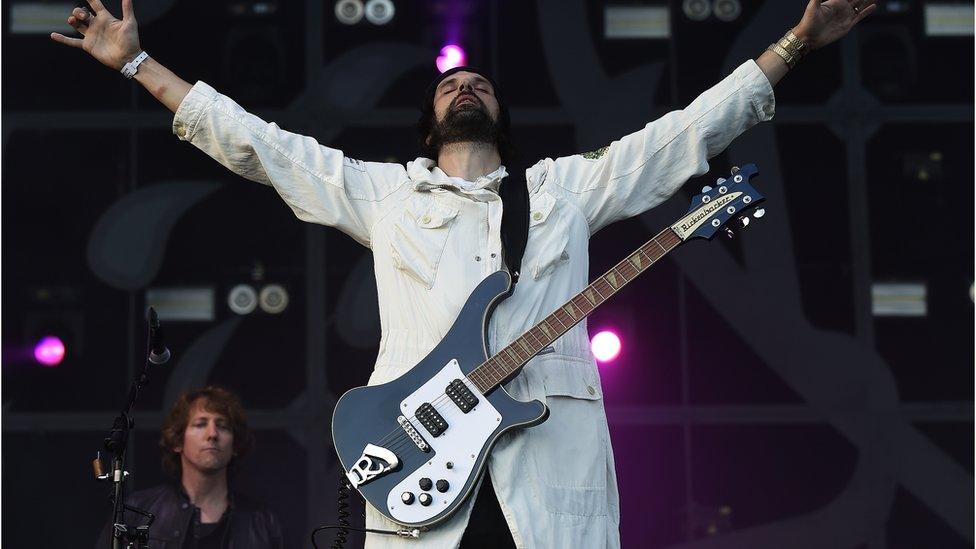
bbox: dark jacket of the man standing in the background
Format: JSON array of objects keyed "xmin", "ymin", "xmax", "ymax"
[{"xmin": 95, "ymin": 484, "xmax": 283, "ymax": 549}]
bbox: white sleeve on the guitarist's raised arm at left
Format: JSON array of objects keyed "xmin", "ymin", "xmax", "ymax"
[{"xmin": 173, "ymin": 82, "xmax": 407, "ymax": 246}]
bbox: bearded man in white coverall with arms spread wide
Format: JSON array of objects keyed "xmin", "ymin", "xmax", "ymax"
[{"xmin": 52, "ymin": 0, "xmax": 875, "ymax": 549}]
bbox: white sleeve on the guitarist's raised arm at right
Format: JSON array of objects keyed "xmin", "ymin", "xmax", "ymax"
[{"xmin": 545, "ymin": 60, "xmax": 775, "ymax": 234}]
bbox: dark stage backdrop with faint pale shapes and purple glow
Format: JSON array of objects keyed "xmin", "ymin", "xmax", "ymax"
[{"xmin": 2, "ymin": 0, "xmax": 974, "ymax": 549}]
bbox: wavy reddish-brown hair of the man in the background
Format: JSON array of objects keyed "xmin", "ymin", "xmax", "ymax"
[{"xmin": 159, "ymin": 385, "xmax": 254, "ymax": 479}]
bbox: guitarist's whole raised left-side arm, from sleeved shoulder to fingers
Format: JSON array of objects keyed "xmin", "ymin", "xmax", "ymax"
[{"xmin": 51, "ymin": 0, "xmax": 407, "ymax": 246}]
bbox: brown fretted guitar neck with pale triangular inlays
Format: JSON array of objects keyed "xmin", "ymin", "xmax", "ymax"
[{"xmin": 468, "ymin": 227, "xmax": 683, "ymax": 393}]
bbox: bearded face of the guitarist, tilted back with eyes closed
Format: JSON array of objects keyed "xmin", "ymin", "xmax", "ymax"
[{"xmin": 428, "ymin": 71, "xmax": 500, "ymax": 150}]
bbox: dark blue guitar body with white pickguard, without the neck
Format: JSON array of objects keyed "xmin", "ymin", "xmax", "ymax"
[{"xmin": 332, "ymin": 271, "xmax": 549, "ymax": 527}]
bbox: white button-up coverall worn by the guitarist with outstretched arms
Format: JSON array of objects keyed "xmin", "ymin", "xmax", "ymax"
[{"xmin": 173, "ymin": 60, "xmax": 774, "ymax": 549}]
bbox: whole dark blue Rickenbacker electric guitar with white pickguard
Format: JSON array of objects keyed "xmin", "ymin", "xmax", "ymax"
[{"xmin": 332, "ymin": 164, "xmax": 765, "ymax": 529}]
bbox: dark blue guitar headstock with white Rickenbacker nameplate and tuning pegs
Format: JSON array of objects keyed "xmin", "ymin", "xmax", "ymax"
[{"xmin": 671, "ymin": 164, "xmax": 766, "ymax": 240}]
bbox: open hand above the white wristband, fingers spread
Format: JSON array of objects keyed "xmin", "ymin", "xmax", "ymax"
[{"xmin": 51, "ymin": 0, "xmax": 142, "ymax": 70}]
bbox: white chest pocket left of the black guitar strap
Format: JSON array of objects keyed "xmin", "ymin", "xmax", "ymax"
[{"xmin": 390, "ymin": 199, "xmax": 458, "ymax": 290}]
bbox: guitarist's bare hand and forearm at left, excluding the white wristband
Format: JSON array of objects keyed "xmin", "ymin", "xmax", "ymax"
[{"xmin": 51, "ymin": 0, "xmax": 191, "ymax": 113}]
